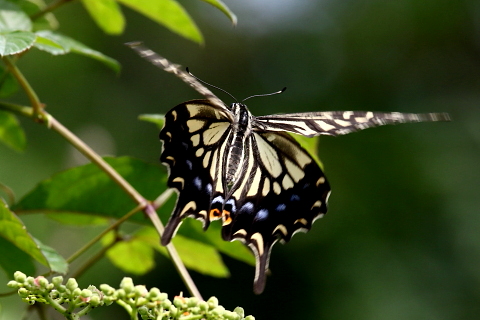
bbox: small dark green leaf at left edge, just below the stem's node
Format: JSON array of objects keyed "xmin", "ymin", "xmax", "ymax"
[{"xmin": 0, "ymin": 110, "xmax": 27, "ymax": 151}]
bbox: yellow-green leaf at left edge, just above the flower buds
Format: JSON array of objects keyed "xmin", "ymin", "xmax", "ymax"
[{"xmin": 0, "ymin": 199, "xmax": 48, "ymax": 266}]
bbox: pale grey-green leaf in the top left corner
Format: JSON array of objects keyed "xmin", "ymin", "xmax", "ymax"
[{"xmin": 0, "ymin": 0, "xmax": 32, "ymax": 33}]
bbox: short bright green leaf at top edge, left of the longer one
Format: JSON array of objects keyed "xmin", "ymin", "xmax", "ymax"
[{"xmin": 82, "ymin": 0, "xmax": 125, "ymax": 35}]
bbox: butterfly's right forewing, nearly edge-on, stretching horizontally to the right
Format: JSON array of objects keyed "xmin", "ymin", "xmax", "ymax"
[{"xmin": 253, "ymin": 111, "xmax": 450, "ymax": 137}]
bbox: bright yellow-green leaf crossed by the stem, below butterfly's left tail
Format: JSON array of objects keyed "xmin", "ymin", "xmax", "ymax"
[{"xmin": 135, "ymin": 228, "xmax": 230, "ymax": 278}]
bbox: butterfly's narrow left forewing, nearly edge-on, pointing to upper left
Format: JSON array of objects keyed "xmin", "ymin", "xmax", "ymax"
[{"xmin": 126, "ymin": 42, "xmax": 233, "ymax": 122}]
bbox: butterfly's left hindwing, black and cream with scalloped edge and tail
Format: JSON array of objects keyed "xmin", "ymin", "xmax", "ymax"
[{"xmin": 160, "ymin": 100, "xmax": 231, "ymax": 245}]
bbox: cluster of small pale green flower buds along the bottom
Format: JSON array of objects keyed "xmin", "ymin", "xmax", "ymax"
[{"xmin": 8, "ymin": 271, "xmax": 255, "ymax": 320}]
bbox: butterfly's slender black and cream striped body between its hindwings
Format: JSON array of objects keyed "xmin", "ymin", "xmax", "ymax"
[{"xmin": 225, "ymin": 103, "xmax": 252, "ymax": 189}]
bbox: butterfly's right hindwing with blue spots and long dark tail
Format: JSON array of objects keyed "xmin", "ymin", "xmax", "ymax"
[{"xmin": 222, "ymin": 133, "xmax": 330, "ymax": 294}]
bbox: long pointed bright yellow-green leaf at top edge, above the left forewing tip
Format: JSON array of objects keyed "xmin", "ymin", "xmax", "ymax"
[{"xmin": 117, "ymin": 0, "xmax": 203, "ymax": 43}]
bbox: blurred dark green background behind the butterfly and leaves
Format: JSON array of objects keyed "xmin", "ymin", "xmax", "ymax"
[{"xmin": 0, "ymin": 0, "xmax": 480, "ymax": 320}]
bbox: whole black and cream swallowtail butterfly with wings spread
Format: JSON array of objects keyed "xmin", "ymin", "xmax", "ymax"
[{"xmin": 127, "ymin": 43, "xmax": 450, "ymax": 294}]
